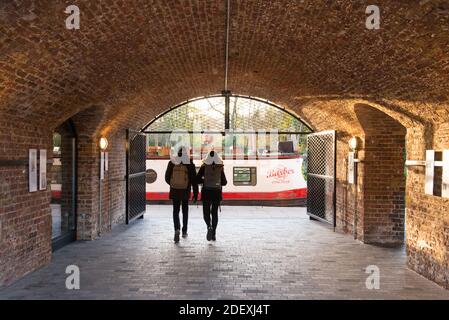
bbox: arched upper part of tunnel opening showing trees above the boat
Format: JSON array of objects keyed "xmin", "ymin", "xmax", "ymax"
[{"xmin": 142, "ymin": 95, "xmax": 312, "ymax": 157}]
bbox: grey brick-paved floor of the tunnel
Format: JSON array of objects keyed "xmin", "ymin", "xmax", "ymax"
[{"xmin": 0, "ymin": 206, "xmax": 449, "ymax": 299}]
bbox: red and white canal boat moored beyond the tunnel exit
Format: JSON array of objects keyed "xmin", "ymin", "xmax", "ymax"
[{"xmin": 146, "ymin": 154, "xmax": 307, "ymax": 205}]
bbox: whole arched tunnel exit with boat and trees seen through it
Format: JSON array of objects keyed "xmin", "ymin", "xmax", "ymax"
[{"xmin": 142, "ymin": 94, "xmax": 313, "ymax": 207}]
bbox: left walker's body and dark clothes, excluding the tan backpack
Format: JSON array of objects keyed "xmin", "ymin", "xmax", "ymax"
[{"xmin": 165, "ymin": 148, "xmax": 198, "ymax": 243}]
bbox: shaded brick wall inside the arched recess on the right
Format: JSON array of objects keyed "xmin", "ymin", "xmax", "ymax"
[{"xmin": 354, "ymin": 104, "xmax": 406, "ymax": 245}]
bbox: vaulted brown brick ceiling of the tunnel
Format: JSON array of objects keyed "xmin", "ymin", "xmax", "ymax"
[{"xmin": 0, "ymin": 0, "xmax": 449, "ymax": 132}]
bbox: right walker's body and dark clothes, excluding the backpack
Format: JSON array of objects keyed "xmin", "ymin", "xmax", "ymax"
[{"xmin": 196, "ymin": 151, "xmax": 228, "ymax": 241}]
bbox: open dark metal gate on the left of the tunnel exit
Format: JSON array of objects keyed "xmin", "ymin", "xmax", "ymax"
[{"xmin": 126, "ymin": 129, "xmax": 147, "ymax": 224}]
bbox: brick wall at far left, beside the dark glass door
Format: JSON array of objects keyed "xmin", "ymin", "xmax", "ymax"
[{"xmin": 0, "ymin": 117, "xmax": 52, "ymax": 286}]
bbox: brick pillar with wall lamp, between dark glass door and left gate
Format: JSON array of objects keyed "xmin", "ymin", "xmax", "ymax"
[{"xmin": 72, "ymin": 107, "xmax": 126, "ymax": 240}]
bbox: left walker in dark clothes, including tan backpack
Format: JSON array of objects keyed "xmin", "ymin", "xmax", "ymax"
[{"xmin": 165, "ymin": 147, "xmax": 198, "ymax": 243}]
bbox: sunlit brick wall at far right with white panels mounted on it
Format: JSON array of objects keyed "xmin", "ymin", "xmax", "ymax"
[{"xmin": 407, "ymin": 123, "xmax": 449, "ymax": 289}]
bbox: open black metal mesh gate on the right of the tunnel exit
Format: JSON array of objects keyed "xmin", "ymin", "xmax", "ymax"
[{"xmin": 307, "ymin": 131, "xmax": 337, "ymax": 228}]
